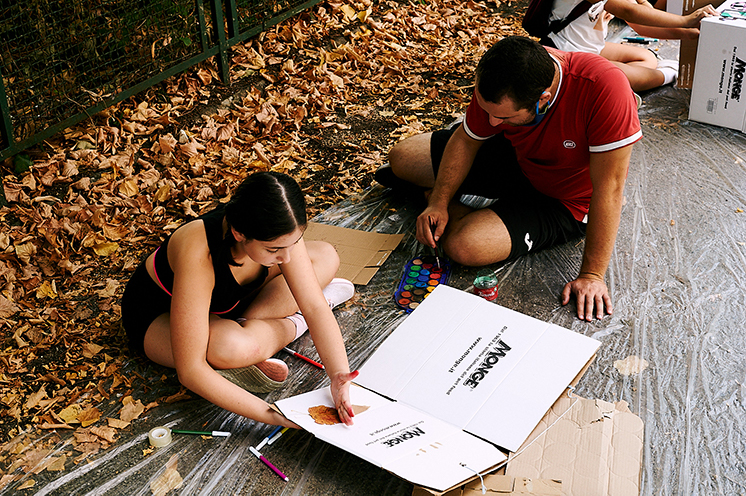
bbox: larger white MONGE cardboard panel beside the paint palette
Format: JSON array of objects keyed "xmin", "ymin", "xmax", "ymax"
[{"xmin": 357, "ymin": 286, "xmax": 600, "ymax": 451}]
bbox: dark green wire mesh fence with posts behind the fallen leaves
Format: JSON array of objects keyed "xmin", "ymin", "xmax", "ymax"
[{"xmin": 0, "ymin": 0, "xmax": 317, "ymax": 159}]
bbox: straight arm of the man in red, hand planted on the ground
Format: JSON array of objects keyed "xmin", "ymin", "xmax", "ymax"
[{"xmin": 562, "ymin": 145, "xmax": 632, "ymax": 321}]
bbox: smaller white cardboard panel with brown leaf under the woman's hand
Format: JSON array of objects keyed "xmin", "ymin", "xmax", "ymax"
[{"xmin": 276, "ymin": 386, "xmax": 507, "ymax": 490}]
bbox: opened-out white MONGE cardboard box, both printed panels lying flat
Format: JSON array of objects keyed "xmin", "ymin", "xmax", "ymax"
[{"xmin": 276, "ymin": 285, "xmax": 600, "ymax": 492}]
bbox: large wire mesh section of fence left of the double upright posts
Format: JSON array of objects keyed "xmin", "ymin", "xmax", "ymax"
[{"xmin": 0, "ymin": 0, "xmax": 202, "ymax": 144}]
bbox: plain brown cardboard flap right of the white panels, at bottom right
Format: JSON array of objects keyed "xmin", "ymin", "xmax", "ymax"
[{"xmin": 506, "ymin": 395, "xmax": 644, "ymax": 496}]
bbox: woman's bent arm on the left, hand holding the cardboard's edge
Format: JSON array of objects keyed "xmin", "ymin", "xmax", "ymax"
[{"xmin": 168, "ymin": 222, "xmax": 296, "ymax": 427}]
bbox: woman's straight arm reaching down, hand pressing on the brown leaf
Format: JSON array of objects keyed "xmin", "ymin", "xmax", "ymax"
[{"xmin": 280, "ymin": 239, "xmax": 357, "ymax": 425}]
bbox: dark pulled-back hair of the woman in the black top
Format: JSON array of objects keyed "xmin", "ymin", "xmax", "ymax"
[{"xmin": 224, "ymin": 172, "xmax": 308, "ymax": 260}]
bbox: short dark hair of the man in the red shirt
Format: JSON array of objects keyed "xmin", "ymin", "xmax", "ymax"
[{"xmin": 476, "ymin": 36, "xmax": 555, "ymax": 110}]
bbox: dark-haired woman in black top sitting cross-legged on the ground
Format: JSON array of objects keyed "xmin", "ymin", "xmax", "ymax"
[{"xmin": 122, "ymin": 172, "xmax": 357, "ymax": 427}]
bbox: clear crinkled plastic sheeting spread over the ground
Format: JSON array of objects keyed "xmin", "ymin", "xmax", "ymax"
[{"xmin": 8, "ymin": 47, "xmax": 746, "ymax": 495}]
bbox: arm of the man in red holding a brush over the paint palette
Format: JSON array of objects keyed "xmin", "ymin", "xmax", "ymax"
[{"xmin": 417, "ymin": 125, "xmax": 483, "ymax": 248}]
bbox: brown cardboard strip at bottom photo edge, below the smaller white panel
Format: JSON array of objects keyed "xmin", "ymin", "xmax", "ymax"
[{"xmin": 412, "ymin": 474, "xmax": 562, "ymax": 496}]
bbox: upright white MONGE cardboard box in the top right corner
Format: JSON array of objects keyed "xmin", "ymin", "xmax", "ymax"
[{"xmin": 689, "ymin": 0, "xmax": 746, "ymax": 131}]
